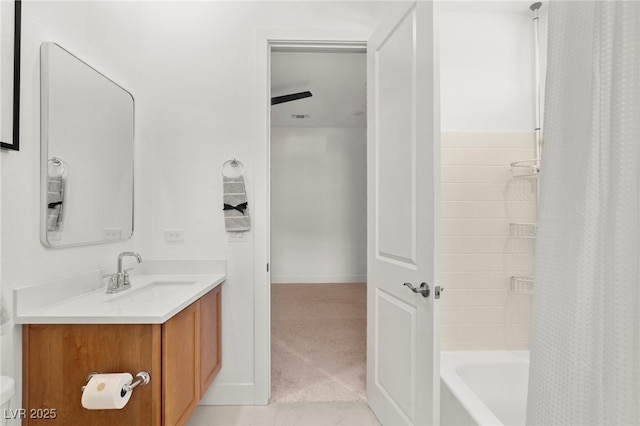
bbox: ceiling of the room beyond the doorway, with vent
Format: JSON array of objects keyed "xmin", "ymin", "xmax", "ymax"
[{"xmin": 271, "ymin": 51, "xmax": 367, "ymax": 127}]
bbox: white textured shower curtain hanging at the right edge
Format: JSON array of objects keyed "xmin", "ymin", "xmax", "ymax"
[{"xmin": 527, "ymin": 1, "xmax": 640, "ymax": 425}]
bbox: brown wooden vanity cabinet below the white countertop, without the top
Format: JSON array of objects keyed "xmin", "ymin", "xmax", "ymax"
[{"xmin": 20, "ymin": 285, "xmax": 222, "ymax": 426}]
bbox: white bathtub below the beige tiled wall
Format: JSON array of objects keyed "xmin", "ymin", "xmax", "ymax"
[{"xmin": 440, "ymin": 351, "xmax": 529, "ymax": 426}]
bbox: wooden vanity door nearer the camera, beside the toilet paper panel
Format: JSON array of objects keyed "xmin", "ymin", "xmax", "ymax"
[{"xmin": 162, "ymin": 300, "xmax": 200, "ymax": 426}]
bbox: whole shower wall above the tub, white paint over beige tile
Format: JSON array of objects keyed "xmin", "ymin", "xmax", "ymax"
[{"xmin": 440, "ymin": 1, "xmax": 547, "ymax": 350}]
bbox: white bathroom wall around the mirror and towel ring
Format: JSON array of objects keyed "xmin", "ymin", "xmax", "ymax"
[{"xmin": 2, "ymin": 1, "xmax": 388, "ymax": 406}]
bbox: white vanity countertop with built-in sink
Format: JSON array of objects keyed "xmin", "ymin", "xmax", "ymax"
[{"xmin": 14, "ymin": 261, "xmax": 226, "ymax": 324}]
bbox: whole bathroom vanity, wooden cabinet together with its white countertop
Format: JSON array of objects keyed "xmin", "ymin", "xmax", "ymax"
[{"xmin": 16, "ymin": 262, "xmax": 225, "ymax": 426}]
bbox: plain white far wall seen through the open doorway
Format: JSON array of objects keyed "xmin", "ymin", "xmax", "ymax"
[{"xmin": 271, "ymin": 127, "xmax": 367, "ymax": 283}]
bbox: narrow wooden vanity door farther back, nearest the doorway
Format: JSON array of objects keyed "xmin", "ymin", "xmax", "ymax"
[{"xmin": 200, "ymin": 285, "xmax": 222, "ymax": 397}]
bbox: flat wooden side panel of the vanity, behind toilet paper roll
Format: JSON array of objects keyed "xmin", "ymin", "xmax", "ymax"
[{"xmin": 22, "ymin": 324, "xmax": 162, "ymax": 426}]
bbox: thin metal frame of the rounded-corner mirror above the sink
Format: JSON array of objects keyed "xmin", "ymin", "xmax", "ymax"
[{"xmin": 40, "ymin": 42, "xmax": 136, "ymax": 249}]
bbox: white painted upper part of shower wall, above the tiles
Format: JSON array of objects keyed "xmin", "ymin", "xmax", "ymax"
[{"xmin": 440, "ymin": 1, "xmax": 547, "ymax": 132}]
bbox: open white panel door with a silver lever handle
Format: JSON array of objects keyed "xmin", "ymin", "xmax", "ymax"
[{"xmin": 367, "ymin": 1, "xmax": 440, "ymax": 425}]
